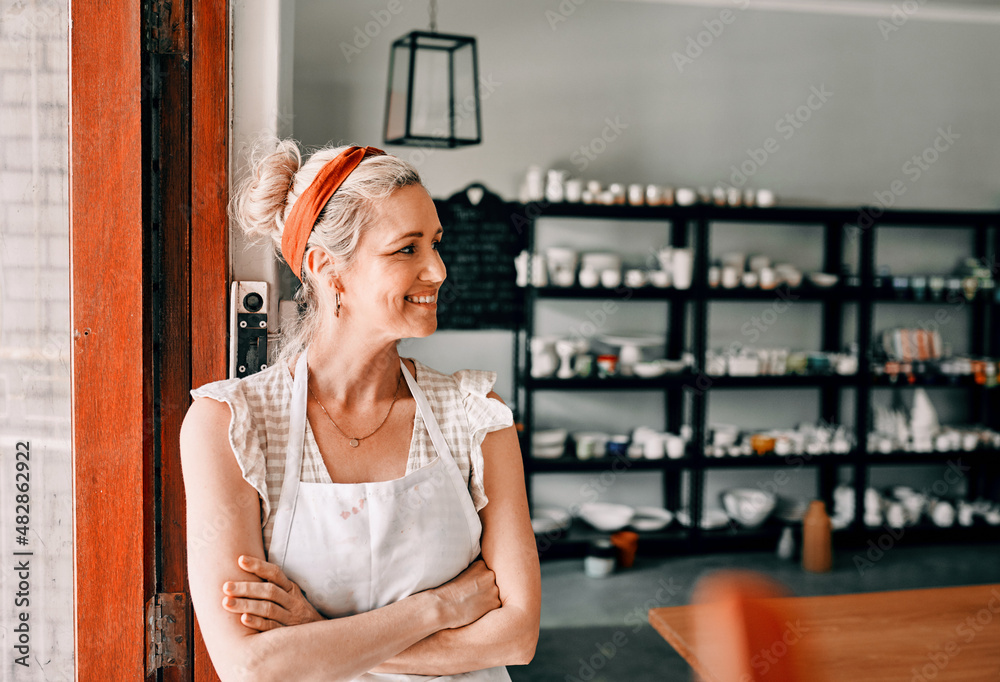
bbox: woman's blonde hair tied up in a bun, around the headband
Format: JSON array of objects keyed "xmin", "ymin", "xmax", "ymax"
[{"xmin": 229, "ymin": 138, "xmax": 423, "ymax": 363}]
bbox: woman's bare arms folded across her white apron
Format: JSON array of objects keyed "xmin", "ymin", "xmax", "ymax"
[{"xmin": 181, "ymin": 394, "xmax": 540, "ymax": 680}]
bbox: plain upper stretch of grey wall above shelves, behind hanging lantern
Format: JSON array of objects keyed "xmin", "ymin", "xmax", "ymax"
[{"xmin": 294, "ymin": 0, "xmax": 1000, "ymax": 208}]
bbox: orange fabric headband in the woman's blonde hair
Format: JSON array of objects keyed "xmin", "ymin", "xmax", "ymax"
[{"xmin": 281, "ymin": 147, "xmax": 385, "ymax": 280}]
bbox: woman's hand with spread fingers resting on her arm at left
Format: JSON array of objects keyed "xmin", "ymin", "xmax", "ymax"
[{"xmin": 222, "ymin": 555, "xmax": 325, "ymax": 632}]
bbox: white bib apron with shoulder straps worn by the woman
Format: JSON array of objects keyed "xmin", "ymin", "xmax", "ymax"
[{"xmin": 268, "ymin": 349, "xmax": 510, "ymax": 682}]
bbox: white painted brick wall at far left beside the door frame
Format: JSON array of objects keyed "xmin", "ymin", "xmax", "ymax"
[{"xmin": 0, "ymin": 0, "xmax": 73, "ymax": 682}]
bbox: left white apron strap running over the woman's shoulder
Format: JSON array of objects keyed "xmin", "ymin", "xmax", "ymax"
[{"xmin": 267, "ymin": 348, "xmax": 309, "ymax": 566}]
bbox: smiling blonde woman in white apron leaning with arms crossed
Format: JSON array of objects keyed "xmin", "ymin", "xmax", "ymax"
[{"xmin": 181, "ymin": 141, "xmax": 540, "ymax": 681}]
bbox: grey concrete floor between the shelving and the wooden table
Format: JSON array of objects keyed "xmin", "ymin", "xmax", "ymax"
[{"xmin": 508, "ymin": 545, "xmax": 1000, "ymax": 682}]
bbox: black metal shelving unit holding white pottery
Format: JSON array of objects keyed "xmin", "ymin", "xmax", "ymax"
[{"xmin": 515, "ymin": 199, "xmax": 1000, "ymax": 557}]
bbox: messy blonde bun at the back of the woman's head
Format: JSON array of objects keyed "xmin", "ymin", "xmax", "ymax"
[{"xmin": 231, "ymin": 138, "xmax": 302, "ymax": 249}]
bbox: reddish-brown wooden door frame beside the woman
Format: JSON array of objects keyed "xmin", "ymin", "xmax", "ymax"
[{"xmin": 69, "ymin": 0, "xmax": 230, "ymax": 682}]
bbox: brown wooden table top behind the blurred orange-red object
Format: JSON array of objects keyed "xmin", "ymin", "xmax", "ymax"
[{"xmin": 649, "ymin": 584, "xmax": 1000, "ymax": 682}]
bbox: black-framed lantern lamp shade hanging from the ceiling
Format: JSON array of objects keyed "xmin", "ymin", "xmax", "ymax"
[{"xmin": 385, "ymin": 31, "xmax": 482, "ymax": 147}]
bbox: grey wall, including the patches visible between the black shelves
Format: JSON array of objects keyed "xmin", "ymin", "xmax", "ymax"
[{"xmin": 294, "ymin": 0, "xmax": 1000, "ymax": 505}]
